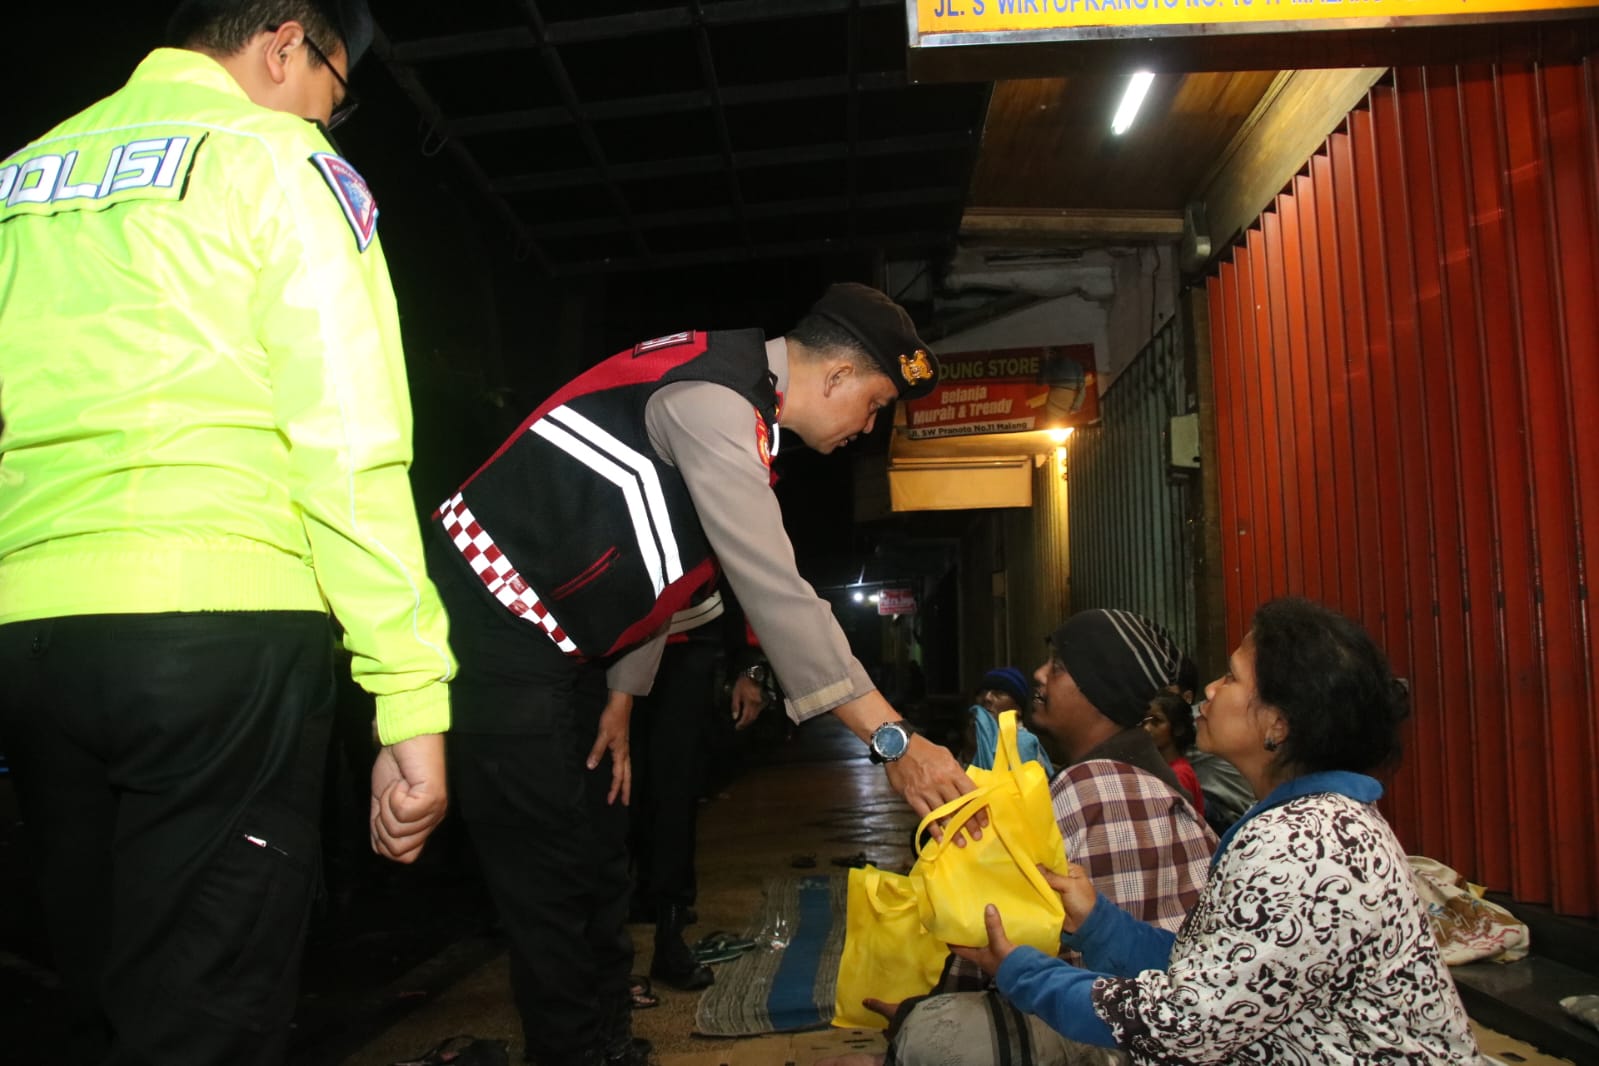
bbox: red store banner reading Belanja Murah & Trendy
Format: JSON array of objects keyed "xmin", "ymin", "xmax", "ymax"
[{"xmin": 905, "ymin": 344, "xmax": 1099, "ymax": 441}]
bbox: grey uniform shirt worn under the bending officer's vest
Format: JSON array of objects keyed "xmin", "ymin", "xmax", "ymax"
[{"xmin": 606, "ymin": 340, "xmax": 876, "ymax": 722}]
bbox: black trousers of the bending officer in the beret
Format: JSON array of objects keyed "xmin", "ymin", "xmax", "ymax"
[{"xmin": 429, "ymin": 539, "xmax": 633, "ymax": 1066}]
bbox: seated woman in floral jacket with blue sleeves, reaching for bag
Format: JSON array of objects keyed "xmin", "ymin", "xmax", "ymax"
[{"xmin": 955, "ymin": 599, "xmax": 1482, "ymax": 1066}]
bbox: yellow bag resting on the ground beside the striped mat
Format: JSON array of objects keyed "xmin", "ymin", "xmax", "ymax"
[{"xmin": 833, "ymin": 866, "xmax": 950, "ymax": 1029}]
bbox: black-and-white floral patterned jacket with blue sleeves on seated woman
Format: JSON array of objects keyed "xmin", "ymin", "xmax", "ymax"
[{"xmin": 998, "ymin": 774, "xmax": 1482, "ymax": 1066}]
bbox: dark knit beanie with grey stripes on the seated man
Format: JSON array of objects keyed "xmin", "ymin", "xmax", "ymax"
[{"xmin": 1049, "ymin": 609, "xmax": 1183, "ymax": 726}]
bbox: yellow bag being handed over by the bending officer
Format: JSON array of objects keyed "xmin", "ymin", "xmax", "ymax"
[{"xmin": 910, "ymin": 711, "xmax": 1067, "ymax": 956}]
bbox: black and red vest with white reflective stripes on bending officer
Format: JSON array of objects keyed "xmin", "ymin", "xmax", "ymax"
[{"xmin": 433, "ymin": 329, "xmax": 777, "ymax": 658}]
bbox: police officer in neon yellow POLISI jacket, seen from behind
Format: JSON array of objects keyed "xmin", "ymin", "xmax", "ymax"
[{"xmin": 0, "ymin": 0, "xmax": 454, "ymax": 1064}]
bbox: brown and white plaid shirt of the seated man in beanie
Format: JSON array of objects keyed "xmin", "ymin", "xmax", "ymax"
[{"xmin": 937, "ymin": 750, "xmax": 1217, "ymax": 992}]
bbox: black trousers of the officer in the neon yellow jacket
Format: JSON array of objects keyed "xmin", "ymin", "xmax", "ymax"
[{"xmin": 0, "ymin": 612, "xmax": 334, "ymax": 1066}]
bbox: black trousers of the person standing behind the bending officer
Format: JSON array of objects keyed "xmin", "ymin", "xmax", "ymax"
[{"xmin": 632, "ymin": 641, "xmax": 719, "ymax": 908}]
